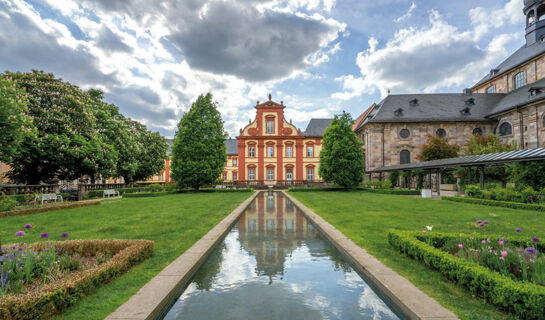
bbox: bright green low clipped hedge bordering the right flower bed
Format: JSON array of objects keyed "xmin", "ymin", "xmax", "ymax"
[{"xmin": 388, "ymin": 230, "xmax": 545, "ymax": 319}]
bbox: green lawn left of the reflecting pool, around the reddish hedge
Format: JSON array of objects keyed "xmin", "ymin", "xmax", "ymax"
[{"xmin": 0, "ymin": 192, "xmax": 251, "ymax": 320}]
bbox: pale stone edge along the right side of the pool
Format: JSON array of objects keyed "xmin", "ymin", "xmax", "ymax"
[{"xmin": 282, "ymin": 191, "xmax": 459, "ymax": 320}]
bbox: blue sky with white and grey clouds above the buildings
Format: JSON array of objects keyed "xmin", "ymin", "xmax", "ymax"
[{"xmin": 0, "ymin": 0, "xmax": 525, "ymax": 137}]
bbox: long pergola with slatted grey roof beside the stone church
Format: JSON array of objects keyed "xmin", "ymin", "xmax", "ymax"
[{"xmin": 365, "ymin": 148, "xmax": 545, "ymax": 194}]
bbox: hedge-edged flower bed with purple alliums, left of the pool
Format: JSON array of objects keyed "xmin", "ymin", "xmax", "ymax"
[{"xmin": 0, "ymin": 239, "xmax": 153, "ymax": 319}]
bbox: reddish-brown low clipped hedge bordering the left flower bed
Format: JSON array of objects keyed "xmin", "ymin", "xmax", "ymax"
[{"xmin": 0, "ymin": 239, "xmax": 153, "ymax": 320}]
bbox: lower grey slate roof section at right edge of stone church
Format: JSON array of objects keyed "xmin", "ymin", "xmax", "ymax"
[{"xmin": 489, "ymin": 78, "xmax": 545, "ymax": 116}]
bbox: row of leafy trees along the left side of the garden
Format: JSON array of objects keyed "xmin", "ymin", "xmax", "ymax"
[{"xmin": 0, "ymin": 70, "xmax": 168, "ymax": 184}]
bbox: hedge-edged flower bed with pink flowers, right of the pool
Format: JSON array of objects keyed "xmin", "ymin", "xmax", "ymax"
[{"xmin": 388, "ymin": 230, "xmax": 545, "ymax": 319}]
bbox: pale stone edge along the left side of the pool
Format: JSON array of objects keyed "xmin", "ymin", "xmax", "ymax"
[{"xmin": 106, "ymin": 191, "xmax": 259, "ymax": 320}]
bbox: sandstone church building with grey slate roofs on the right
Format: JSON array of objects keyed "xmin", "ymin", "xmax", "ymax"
[{"xmin": 353, "ymin": 0, "xmax": 545, "ymax": 171}]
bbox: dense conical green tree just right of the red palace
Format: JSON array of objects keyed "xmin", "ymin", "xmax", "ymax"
[{"xmin": 320, "ymin": 111, "xmax": 365, "ymax": 189}]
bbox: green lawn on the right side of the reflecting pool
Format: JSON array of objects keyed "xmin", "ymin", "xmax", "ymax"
[{"xmin": 291, "ymin": 191, "xmax": 545, "ymax": 320}]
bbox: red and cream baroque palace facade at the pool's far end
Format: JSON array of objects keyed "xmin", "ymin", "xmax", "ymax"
[{"xmin": 221, "ymin": 94, "xmax": 331, "ymax": 185}]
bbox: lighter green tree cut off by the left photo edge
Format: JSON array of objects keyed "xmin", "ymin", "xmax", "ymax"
[{"xmin": 0, "ymin": 74, "xmax": 34, "ymax": 163}]
